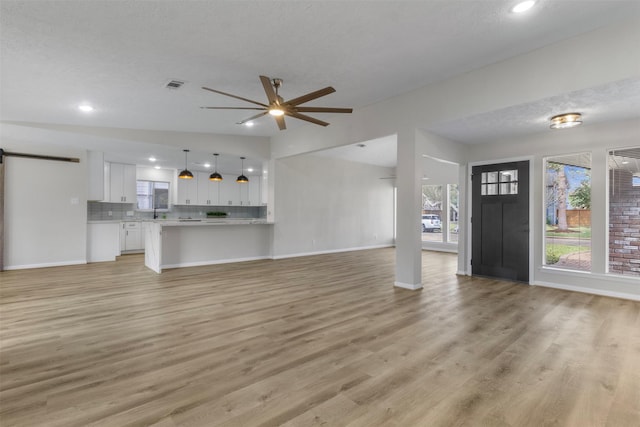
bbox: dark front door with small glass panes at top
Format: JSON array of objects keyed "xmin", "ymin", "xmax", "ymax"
[{"xmin": 471, "ymin": 161, "xmax": 529, "ymax": 282}]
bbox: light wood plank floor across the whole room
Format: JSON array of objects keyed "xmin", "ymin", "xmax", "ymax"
[{"xmin": 0, "ymin": 249, "xmax": 640, "ymax": 427}]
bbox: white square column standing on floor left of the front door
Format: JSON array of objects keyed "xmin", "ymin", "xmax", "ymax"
[{"xmin": 395, "ymin": 131, "xmax": 422, "ymax": 289}]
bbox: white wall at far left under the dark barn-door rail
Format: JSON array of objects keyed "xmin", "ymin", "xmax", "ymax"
[{"xmin": 2, "ymin": 140, "xmax": 87, "ymax": 270}]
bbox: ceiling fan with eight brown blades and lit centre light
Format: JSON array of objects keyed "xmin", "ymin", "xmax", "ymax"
[{"xmin": 200, "ymin": 76, "xmax": 353, "ymax": 130}]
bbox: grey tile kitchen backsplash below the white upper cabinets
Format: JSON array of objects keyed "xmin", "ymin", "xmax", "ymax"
[{"xmin": 87, "ymin": 202, "xmax": 267, "ymax": 221}]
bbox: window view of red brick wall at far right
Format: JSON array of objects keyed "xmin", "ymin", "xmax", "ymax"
[{"xmin": 609, "ymin": 147, "xmax": 640, "ymax": 276}]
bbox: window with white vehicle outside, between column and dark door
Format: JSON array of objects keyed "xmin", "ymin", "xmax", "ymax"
[{"xmin": 422, "ymin": 184, "xmax": 458, "ymax": 243}]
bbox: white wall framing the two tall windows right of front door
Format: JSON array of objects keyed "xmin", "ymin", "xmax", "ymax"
[{"xmin": 467, "ymin": 119, "xmax": 640, "ymax": 299}]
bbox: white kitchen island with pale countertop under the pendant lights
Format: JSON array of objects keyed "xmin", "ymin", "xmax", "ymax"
[{"xmin": 144, "ymin": 219, "xmax": 273, "ymax": 273}]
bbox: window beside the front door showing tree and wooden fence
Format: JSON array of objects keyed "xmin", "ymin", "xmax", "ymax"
[{"xmin": 545, "ymin": 153, "xmax": 591, "ymax": 271}]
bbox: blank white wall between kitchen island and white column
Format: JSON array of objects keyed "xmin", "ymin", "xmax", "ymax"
[{"xmin": 274, "ymin": 155, "xmax": 394, "ymax": 257}]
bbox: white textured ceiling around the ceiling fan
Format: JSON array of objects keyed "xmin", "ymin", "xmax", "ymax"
[{"xmin": 0, "ymin": 0, "xmax": 640, "ymax": 168}]
